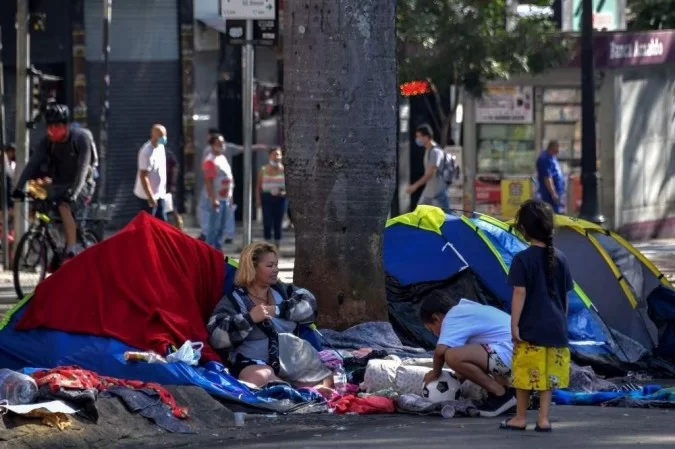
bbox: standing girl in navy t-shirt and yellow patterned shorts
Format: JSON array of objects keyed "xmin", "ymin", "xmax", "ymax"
[{"xmin": 500, "ymin": 200, "xmax": 574, "ymax": 432}]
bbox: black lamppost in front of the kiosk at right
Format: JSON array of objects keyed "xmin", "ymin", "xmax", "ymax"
[{"xmin": 579, "ymin": 0, "xmax": 605, "ymax": 224}]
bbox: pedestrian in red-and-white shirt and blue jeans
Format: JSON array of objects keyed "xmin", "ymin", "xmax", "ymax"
[{"xmin": 201, "ymin": 134, "xmax": 232, "ymax": 250}]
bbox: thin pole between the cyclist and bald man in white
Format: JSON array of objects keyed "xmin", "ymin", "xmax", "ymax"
[{"xmin": 98, "ymin": 0, "xmax": 112, "ymax": 203}]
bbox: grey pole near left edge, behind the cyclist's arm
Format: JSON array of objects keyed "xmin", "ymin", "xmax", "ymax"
[{"xmin": 14, "ymin": 0, "xmax": 30, "ymax": 242}]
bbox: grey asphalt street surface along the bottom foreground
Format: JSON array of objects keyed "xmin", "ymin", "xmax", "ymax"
[{"xmin": 145, "ymin": 406, "xmax": 675, "ymax": 449}]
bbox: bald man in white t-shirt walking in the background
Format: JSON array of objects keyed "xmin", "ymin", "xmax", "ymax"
[{"xmin": 134, "ymin": 124, "xmax": 167, "ymax": 221}]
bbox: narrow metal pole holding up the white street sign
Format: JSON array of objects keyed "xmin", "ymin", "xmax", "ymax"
[{"xmin": 241, "ymin": 20, "xmax": 254, "ymax": 246}]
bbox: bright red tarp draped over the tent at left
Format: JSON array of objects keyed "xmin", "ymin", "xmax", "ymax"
[{"xmin": 17, "ymin": 212, "xmax": 225, "ymax": 361}]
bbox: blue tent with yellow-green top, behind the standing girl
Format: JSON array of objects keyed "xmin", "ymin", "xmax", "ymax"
[{"xmin": 384, "ymin": 206, "xmax": 629, "ymax": 367}]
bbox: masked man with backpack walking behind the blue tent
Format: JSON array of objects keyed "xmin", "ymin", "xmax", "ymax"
[{"xmin": 406, "ymin": 125, "xmax": 450, "ymax": 211}]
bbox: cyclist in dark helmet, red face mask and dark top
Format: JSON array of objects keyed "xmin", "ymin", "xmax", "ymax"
[{"xmin": 12, "ymin": 102, "xmax": 95, "ymax": 258}]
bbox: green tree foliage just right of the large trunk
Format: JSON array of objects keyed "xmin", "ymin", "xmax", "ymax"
[{"xmin": 397, "ymin": 0, "xmax": 569, "ymax": 101}]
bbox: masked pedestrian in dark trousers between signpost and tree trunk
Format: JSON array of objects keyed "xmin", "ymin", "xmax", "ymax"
[{"xmin": 256, "ymin": 148, "xmax": 287, "ymax": 248}]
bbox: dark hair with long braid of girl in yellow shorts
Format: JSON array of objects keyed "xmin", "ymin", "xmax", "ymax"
[{"xmin": 516, "ymin": 200, "xmax": 557, "ymax": 298}]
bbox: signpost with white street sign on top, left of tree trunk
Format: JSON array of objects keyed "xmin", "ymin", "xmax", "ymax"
[{"xmin": 220, "ymin": 0, "xmax": 278, "ymax": 246}]
